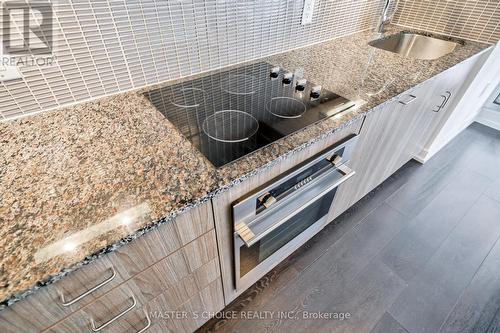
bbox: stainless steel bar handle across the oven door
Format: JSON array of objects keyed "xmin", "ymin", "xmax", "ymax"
[{"xmin": 235, "ymin": 164, "xmax": 356, "ymax": 247}]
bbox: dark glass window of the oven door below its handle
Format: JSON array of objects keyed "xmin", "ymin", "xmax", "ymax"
[{"xmin": 239, "ymin": 188, "xmax": 337, "ymax": 278}]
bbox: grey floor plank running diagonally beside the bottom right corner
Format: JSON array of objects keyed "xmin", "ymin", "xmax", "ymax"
[{"xmin": 389, "ymin": 196, "xmax": 500, "ymax": 333}]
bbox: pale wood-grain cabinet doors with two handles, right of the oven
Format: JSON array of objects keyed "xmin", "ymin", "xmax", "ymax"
[{"xmin": 331, "ymin": 54, "xmax": 485, "ymax": 218}]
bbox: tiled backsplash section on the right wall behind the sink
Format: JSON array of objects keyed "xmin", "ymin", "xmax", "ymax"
[{"xmin": 393, "ymin": 0, "xmax": 500, "ymax": 43}]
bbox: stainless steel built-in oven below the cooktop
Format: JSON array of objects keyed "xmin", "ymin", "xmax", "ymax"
[{"xmin": 233, "ymin": 135, "xmax": 357, "ymax": 290}]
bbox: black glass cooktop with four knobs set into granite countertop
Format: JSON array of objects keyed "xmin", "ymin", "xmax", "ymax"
[{"xmin": 146, "ymin": 62, "xmax": 354, "ymax": 167}]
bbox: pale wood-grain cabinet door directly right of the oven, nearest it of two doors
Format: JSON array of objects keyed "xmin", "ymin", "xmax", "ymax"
[{"xmin": 331, "ymin": 90, "xmax": 421, "ymax": 219}]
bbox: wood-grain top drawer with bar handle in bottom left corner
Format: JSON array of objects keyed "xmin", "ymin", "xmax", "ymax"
[{"xmin": 0, "ymin": 256, "xmax": 123, "ymax": 333}]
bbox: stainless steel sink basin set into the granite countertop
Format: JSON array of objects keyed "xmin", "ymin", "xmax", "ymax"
[{"xmin": 368, "ymin": 32, "xmax": 458, "ymax": 60}]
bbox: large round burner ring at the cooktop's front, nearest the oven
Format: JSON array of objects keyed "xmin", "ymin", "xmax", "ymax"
[{"xmin": 202, "ymin": 110, "xmax": 259, "ymax": 143}]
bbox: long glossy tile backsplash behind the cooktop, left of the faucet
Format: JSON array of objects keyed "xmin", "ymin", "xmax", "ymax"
[{"xmin": 0, "ymin": 0, "xmax": 382, "ymax": 119}]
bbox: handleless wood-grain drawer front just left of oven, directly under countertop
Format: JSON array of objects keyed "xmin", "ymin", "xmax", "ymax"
[{"xmin": 110, "ymin": 202, "xmax": 214, "ymax": 279}]
